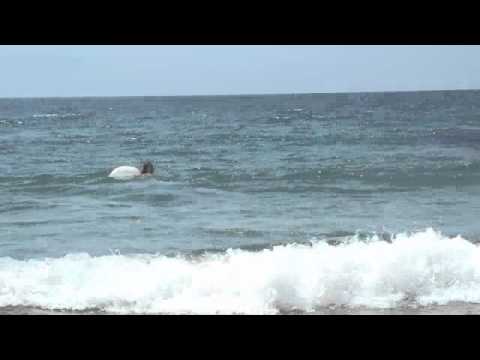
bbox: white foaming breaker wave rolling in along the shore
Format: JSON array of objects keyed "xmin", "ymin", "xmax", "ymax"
[{"xmin": 0, "ymin": 229, "xmax": 480, "ymax": 314}]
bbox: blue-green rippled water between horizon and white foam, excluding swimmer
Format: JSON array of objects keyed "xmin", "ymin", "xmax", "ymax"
[{"xmin": 0, "ymin": 91, "xmax": 480, "ymax": 314}]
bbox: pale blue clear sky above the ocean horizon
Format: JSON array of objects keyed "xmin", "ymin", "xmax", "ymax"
[{"xmin": 0, "ymin": 45, "xmax": 480, "ymax": 97}]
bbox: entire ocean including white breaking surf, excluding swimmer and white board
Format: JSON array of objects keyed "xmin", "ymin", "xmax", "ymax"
[{"xmin": 0, "ymin": 91, "xmax": 480, "ymax": 314}]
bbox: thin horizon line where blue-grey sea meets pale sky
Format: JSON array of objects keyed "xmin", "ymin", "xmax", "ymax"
[{"xmin": 0, "ymin": 88, "xmax": 480, "ymax": 100}]
